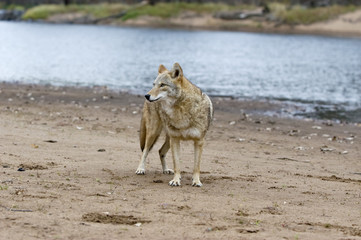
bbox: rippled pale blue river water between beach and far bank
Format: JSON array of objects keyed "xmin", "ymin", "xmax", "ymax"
[{"xmin": 0, "ymin": 22, "xmax": 361, "ymax": 122}]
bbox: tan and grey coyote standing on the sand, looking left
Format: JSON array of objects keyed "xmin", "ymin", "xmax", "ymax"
[{"xmin": 136, "ymin": 63, "xmax": 213, "ymax": 187}]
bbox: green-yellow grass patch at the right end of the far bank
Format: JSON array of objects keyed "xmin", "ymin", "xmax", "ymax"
[{"xmin": 270, "ymin": 3, "xmax": 357, "ymax": 25}]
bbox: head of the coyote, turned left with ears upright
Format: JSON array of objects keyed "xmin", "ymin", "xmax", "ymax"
[{"xmin": 145, "ymin": 63, "xmax": 183, "ymax": 102}]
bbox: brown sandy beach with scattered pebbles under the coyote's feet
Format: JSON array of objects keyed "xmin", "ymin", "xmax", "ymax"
[{"xmin": 0, "ymin": 83, "xmax": 361, "ymax": 240}]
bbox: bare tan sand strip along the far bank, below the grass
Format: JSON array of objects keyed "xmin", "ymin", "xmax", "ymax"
[{"xmin": 109, "ymin": 10, "xmax": 361, "ymax": 38}]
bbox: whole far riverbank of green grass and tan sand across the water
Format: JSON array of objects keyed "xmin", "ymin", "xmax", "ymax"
[{"xmin": 12, "ymin": 2, "xmax": 361, "ymax": 37}]
